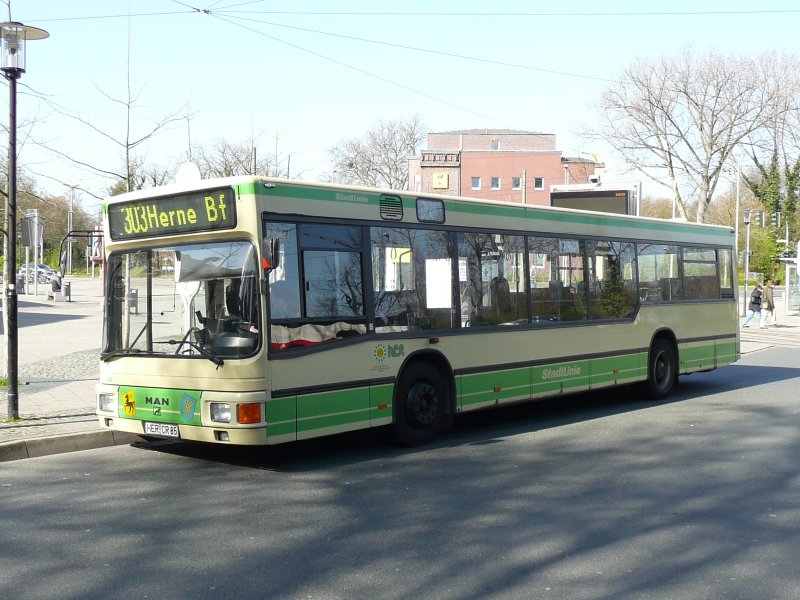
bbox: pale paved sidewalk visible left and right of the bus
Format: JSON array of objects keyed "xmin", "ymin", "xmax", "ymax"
[{"xmin": 0, "ymin": 278, "xmax": 800, "ymax": 462}]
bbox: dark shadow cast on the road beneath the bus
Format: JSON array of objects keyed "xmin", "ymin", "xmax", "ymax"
[{"xmin": 137, "ymin": 356, "xmax": 800, "ymax": 473}]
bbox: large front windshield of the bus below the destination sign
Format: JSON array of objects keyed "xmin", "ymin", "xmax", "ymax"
[{"xmin": 102, "ymin": 240, "xmax": 263, "ymax": 366}]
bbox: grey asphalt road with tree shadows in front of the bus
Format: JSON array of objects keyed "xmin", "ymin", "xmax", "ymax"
[{"xmin": 0, "ymin": 348, "xmax": 800, "ymax": 599}]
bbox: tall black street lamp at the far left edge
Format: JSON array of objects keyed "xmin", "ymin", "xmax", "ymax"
[{"xmin": 0, "ymin": 21, "xmax": 50, "ymax": 420}]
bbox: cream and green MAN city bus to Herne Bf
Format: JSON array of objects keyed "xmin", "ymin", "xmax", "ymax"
[{"xmin": 97, "ymin": 177, "xmax": 740, "ymax": 446}]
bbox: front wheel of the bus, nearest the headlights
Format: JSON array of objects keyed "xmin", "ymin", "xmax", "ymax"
[{"xmin": 393, "ymin": 361, "xmax": 448, "ymax": 446}]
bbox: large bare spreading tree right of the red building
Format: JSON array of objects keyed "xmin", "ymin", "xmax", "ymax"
[{"xmin": 589, "ymin": 49, "xmax": 798, "ymax": 222}]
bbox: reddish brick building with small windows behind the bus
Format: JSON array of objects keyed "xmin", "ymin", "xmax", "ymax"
[{"xmin": 408, "ymin": 129, "xmax": 603, "ymax": 205}]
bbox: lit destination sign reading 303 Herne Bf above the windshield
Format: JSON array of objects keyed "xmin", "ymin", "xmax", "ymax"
[{"xmin": 108, "ymin": 188, "xmax": 236, "ymax": 240}]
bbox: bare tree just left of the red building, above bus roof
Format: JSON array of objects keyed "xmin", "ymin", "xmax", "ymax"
[{"xmin": 329, "ymin": 115, "xmax": 425, "ymax": 190}]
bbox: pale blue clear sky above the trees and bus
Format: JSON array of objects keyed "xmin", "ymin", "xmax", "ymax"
[{"xmin": 6, "ymin": 0, "xmax": 800, "ymax": 212}]
